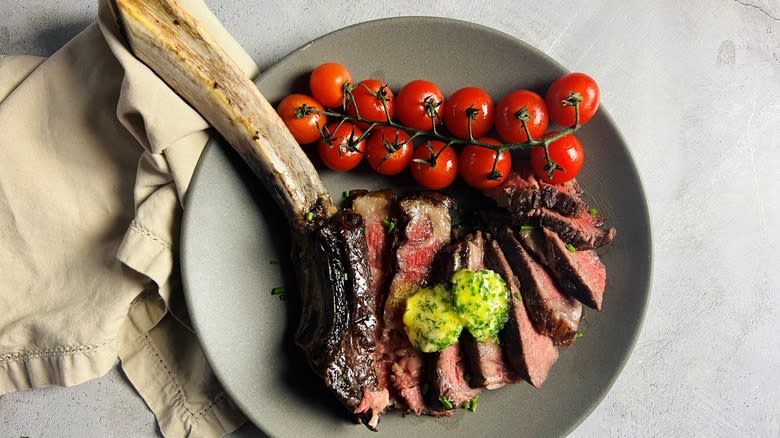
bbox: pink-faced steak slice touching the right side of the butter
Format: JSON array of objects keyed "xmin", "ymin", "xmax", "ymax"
[{"xmin": 485, "ymin": 240, "xmax": 558, "ymax": 388}]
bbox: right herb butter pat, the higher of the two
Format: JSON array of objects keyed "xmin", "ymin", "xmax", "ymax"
[{"xmin": 452, "ymin": 269, "xmax": 509, "ymax": 342}]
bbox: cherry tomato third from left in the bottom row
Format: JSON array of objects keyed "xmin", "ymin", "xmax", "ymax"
[{"xmin": 366, "ymin": 126, "xmax": 414, "ymax": 175}]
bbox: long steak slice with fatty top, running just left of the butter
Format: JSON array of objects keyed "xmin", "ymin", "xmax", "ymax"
[{"xmin": 381, "ymin": 192, "xmax": 453, "ymax": 415}]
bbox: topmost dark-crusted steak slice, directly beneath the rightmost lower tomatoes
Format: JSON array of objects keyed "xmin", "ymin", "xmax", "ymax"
[{"xmin": 485, "ymin": 162, "xmax": 587, "ymax": 216}]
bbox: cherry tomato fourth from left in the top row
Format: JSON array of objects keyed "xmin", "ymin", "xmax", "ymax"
[{"xmin": 444, "ymin": 87, "xmax": 493, "ymax": 140}]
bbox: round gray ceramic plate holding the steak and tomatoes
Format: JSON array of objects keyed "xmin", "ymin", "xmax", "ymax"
[{"xmin": 182, "ymin": 18, "xmax": 651, "ymax": 437}]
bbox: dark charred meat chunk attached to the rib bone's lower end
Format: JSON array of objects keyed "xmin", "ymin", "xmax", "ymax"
[{"xmin": 296, "ymin": 210, "xmax": 384, "ymax": 428}]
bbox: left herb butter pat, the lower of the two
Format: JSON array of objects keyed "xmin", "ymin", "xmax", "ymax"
[{"xmin": 404, "ymin": 284, "xmax": 463, "ymax": 353}]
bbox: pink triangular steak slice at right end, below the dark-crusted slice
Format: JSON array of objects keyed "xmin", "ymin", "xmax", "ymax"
[{"xmin": 542, "ymin": 228, "xmax": 607, "ymax": 310}]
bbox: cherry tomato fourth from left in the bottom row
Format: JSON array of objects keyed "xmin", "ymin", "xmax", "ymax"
[{"xmin": 410, "ymin": 140, "xmax": 458, "ymax": 190}]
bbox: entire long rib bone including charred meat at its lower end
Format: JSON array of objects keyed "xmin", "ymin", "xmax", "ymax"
[{"xmin": 109, "ymin": 0, "xmax": 389, "ymax": 428}]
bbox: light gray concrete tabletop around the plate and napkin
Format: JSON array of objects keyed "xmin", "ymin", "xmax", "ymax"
[{"xmin": 0, "ymin": 0, "xmax": 780, "ymax": 437}]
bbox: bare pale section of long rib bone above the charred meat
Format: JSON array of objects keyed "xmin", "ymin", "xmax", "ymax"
[{"xmin": 115, "ymin": 0, "xmax": 336, "ymax": 222}]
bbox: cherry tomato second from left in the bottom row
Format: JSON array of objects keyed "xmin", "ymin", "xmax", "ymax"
[{"xmin": 317, "ymin": 122, "xmax": 366, "ymax": 172}]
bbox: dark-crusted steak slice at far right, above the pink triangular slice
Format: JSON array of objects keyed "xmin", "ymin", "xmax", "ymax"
[{"xmin": 530, "ymin": 208, "xmax": 615, "ymax": 250}]
